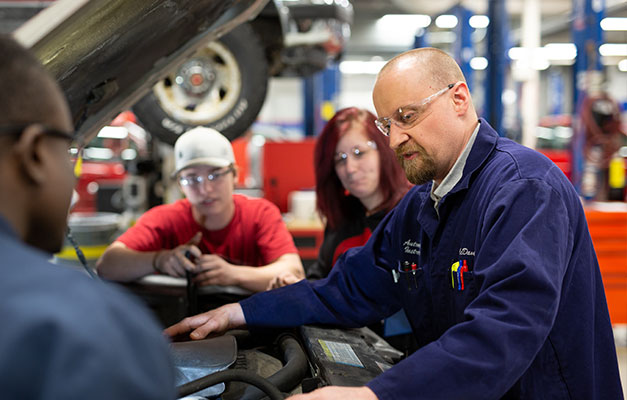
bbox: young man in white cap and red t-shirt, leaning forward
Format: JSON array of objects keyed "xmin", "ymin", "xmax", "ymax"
[{"xmin": 97, "ymin": 127, "xmax": 304, "ymax": 292}]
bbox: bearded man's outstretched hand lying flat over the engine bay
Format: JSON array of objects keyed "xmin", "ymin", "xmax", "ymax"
[{"xmin": 164, "ymin": 303, "xmax": 246, "ymax": 340}]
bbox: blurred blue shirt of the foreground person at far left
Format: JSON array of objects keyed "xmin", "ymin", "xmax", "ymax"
[{"xmin": 0, "ymin": 217, "xmax": 176, "ymax": 400}]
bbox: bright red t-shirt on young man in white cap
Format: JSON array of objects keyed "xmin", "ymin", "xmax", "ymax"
[{"xmin": 117, "ymin": 194, "xmax": 298, "ymax": 267}]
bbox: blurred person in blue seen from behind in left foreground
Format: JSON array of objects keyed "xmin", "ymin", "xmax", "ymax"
[{"xmin": 0, "ymin": 35, "xmax": 175, "ymax": 400}]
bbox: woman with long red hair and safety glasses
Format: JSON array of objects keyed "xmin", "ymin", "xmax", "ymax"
[{"xmin": 271, "ymin": 107, "xmax": 411, "ymax": 287}]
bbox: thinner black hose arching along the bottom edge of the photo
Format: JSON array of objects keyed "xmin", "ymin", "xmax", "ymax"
[{"xmin": 178, "ymin": 369, "xmax": 285, "ymax": 400}]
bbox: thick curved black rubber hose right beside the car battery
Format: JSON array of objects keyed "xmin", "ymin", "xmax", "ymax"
[{"xmin": 241, "ymin": 335, "xmax": 309, "ymax": 400}]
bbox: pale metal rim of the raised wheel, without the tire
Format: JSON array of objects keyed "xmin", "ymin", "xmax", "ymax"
[{"xmin": 153, "ymin": 42, "xmax": 242, "ymax": 125}]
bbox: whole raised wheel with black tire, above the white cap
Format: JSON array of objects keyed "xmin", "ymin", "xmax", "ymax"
[{"xmin": 133, "ymin": 24, "xmax": 268, "ymax": 144}]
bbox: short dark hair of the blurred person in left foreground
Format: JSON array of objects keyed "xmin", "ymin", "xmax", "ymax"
[{"xmin": 0, "ymin": 34, "xmax": 61, "ymax": 125}]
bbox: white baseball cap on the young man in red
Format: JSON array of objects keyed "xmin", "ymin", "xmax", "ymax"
[{"xmin": 172, "ymin": 126, "xmax": 235, "ymax": 176}]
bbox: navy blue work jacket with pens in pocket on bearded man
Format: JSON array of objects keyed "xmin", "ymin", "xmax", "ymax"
[{"xmin": 241, "ymin": 120, "xmax": 622, "ymax": 400}]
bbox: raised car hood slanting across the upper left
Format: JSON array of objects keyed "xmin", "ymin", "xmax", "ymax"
[{"xmin": 14, "ymin": 0, "xmax": 268, "ymax": 141}]
